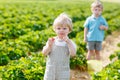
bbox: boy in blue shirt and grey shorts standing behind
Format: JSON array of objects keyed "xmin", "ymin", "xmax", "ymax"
[{"xmin": 84, "ymin": 0, "xmax": 108, "ymax": 60}]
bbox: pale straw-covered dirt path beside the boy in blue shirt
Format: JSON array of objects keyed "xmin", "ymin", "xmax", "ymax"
[{"xmin": 71, "ymin": 32, "xmax": 120, "ymax": 80}]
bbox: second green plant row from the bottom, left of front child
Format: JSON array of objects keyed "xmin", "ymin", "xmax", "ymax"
[{"xmin": 0, "ymin": 29, "xmax": 54, "ymax": 65}]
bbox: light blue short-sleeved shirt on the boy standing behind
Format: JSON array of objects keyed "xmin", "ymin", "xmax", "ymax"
[{"xmin": 84, "ymin": 15, "xmax": 108, "ymax": 41}]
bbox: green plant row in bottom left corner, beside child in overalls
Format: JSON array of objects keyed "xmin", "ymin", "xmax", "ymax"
[{"xmin": 0, "ymin": 53, "xmax": 45, "ymax": 80}]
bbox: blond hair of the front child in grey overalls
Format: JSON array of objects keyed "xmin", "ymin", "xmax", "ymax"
[{"xmin": 53, "ymin": 13, "xmax": 72, "ymax": 32}]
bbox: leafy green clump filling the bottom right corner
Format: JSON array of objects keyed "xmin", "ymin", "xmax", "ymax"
[{"xmin": 92, "ymin": 60, "xmax": 120, "ymax": 80}]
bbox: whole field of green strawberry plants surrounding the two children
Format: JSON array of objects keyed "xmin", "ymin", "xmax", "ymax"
[{"xmin": 0, "ymin": 1, "xmax": 120, "ymax": 80}]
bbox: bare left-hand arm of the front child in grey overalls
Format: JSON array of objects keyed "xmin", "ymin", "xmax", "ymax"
[{"xmin": 42, "ymin": 38, "xmax": 54, "ymax": 56}]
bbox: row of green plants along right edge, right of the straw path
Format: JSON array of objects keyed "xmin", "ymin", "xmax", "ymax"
[{"xmin": 92, "ymin": 43, "xmax": 120, "ymax": 80}]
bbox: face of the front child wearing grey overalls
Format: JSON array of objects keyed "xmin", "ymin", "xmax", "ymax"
[{"xmin": 55, "ymin": 26, "xmax": 70, "ymax": 39}]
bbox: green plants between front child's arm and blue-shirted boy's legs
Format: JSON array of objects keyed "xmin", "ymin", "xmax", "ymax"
[{"xmin": 70, "ymin": 37, "xmax": 87, "ymax": 71}]
